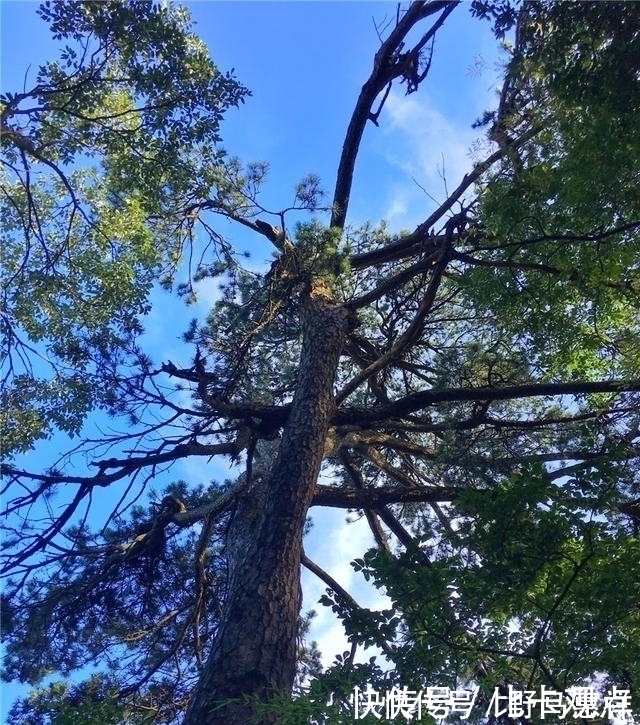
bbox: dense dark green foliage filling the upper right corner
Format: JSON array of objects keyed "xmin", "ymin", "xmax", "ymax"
[{"xmin": 461, "ymin": 3, "xmax": 640, "ymax": 379}]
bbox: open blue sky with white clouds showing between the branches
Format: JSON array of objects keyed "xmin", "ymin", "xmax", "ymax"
[{"xmin": 0, "ymin": 0, "xmax": 508, "ymax": 717}]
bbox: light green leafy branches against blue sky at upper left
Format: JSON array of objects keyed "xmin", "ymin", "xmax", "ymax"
[{"xmin": 0, "ymin": 1, "xmax": 247, "ymax": 455}]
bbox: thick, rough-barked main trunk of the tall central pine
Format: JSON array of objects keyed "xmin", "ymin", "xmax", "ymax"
[{"xmin": 185, "ymin": 293, "xmax": 352, "ymax": 725}]
